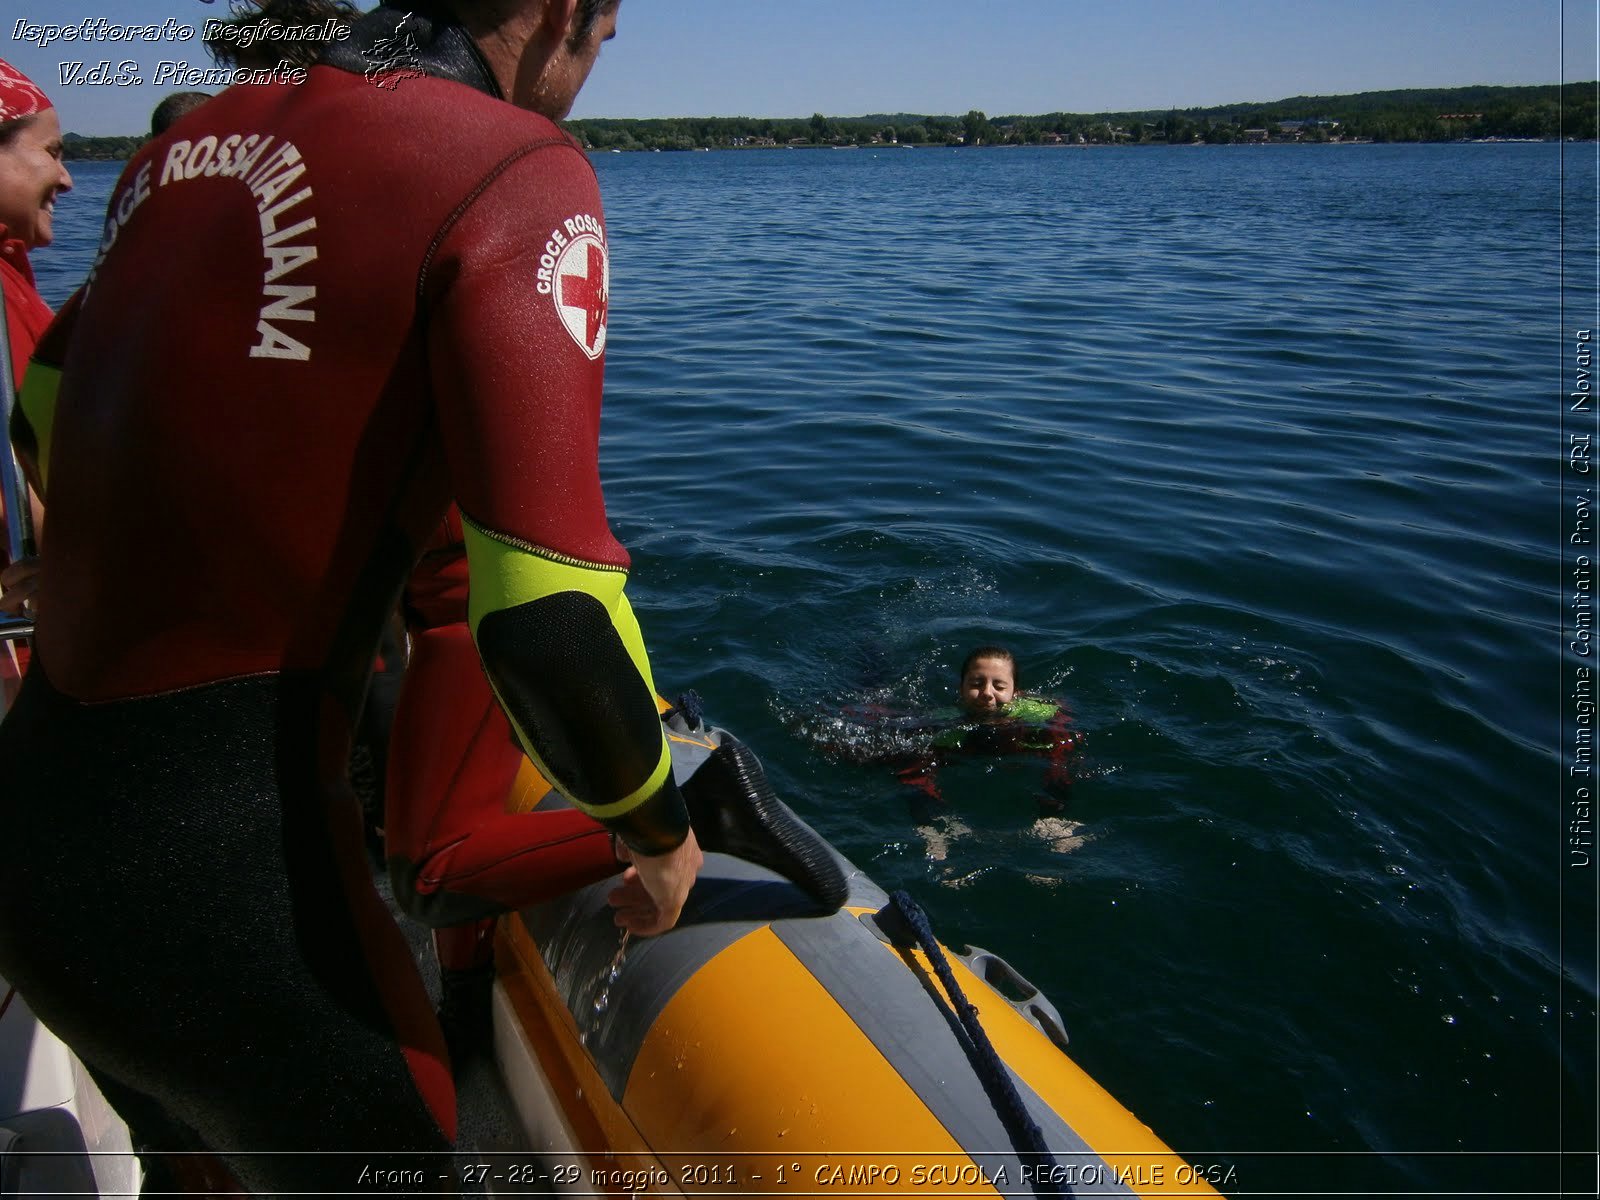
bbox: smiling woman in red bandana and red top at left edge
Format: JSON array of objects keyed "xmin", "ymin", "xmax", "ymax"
[{"xmin": 0, "ymin": 59, "xmax": 72, "ymax": 694}]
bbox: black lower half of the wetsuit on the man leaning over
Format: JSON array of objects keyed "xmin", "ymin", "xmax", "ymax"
[{"xmin": 0, "ymin": 662, "xmax": 454, "ymax": 1194}]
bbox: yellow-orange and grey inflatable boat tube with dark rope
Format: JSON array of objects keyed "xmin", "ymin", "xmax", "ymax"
[{"xmin": 483, "ymin": 710, "xmax": 1214, "ymax": 1195}]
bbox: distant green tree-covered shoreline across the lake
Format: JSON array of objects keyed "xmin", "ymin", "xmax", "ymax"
[{"xmin": 64, "ymin": 83, "xmax": 1595, "ymax": 160}]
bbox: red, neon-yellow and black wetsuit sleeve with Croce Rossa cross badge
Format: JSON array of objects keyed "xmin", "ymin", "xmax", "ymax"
[{"xmin": 421, "ymin": 136, "xmax": 688, "ymax": 853}]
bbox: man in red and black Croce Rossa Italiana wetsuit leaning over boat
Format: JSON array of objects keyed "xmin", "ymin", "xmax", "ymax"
[{"xmin": 0, "ymin": 0, "xmax": 701, "ymax": 1194}]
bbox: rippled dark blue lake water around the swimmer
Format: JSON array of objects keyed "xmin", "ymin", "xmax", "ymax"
[{"xmin": 37, "ymin": 146, "xmax": 1600, "ymax": 1195}]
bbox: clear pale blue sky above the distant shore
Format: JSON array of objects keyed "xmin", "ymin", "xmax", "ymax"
[{"xmin": 0, "ymin": 0, "xmax": 1600, "ymax": 134}]
